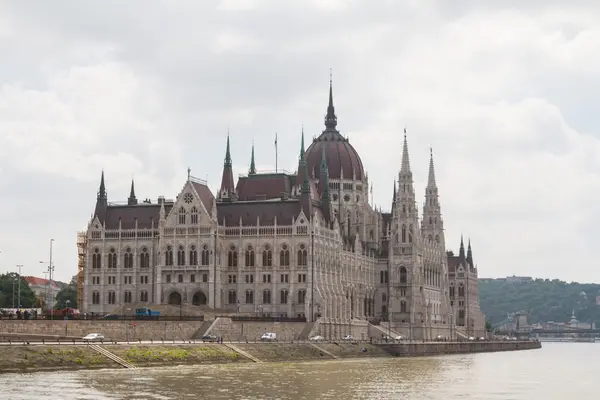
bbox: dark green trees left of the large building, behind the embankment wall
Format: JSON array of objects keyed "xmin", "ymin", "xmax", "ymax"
[{"xmin": 0, "ymin": 272, "xmax": 77, "ymax": 309}]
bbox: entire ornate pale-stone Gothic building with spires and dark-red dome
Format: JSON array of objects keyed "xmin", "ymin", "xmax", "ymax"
[{"xmin": 81, "ymin": 79, "xmax": 483, "ymax": 338}]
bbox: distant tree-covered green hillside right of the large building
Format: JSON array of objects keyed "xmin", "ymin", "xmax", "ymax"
[{"xmin": 479, "ymin": 279, "xmax": 600, "ymax": 325}]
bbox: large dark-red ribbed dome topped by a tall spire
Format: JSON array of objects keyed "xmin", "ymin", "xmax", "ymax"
[{"xmin": 305, "ymin": 81, "xmax": 365, "ymax": 180}]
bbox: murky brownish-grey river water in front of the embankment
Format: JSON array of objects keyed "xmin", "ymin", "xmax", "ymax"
[{"xmin": 0, "ymin": 343, "xmax": 600, "ymax": 400}]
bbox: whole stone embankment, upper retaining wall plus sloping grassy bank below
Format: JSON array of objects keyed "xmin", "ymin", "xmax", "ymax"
[{"xmin": 0, "ymin": 317, "xmax": 541, "ymax": 372}]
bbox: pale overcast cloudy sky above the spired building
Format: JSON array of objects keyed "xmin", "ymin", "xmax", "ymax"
[{"xmin": 0, "ymin": 0, "xmax": 600, "ymax": 282}]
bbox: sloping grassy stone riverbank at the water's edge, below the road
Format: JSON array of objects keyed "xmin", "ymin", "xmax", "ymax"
[{"xmin": 0, "ymin": 341, "xmax": 541, "ymax": 373}]
